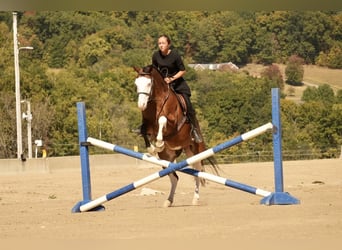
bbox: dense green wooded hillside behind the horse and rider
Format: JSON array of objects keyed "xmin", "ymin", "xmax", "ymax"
[{"xmin": 0, "ymin": 11, "xmax": 342, "ymax": 162}]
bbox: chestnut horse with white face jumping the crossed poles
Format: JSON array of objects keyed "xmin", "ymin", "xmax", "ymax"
[{"xmin": 133, "ymin": 65, "xmax": 218, "ymax": 207}]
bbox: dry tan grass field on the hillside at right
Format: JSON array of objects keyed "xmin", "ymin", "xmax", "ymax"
[{"xmin": 242, "ymin": 64, "xmax": 342, "ymax": 101}]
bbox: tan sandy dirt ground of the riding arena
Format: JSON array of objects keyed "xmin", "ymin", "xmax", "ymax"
[{"xmin": 0, "ymin": 159, "xmax": 342, "ymax": 249}]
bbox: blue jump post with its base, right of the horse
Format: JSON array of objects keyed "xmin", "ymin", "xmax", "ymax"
[{"xmin": 260, "ymin": 88, "xmax": 300, "ymax": 205}]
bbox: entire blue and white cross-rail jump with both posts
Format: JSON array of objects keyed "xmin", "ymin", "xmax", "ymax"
[{"xmin": 72, "ymin": 89, "xmax": 299, "ymax": 212}]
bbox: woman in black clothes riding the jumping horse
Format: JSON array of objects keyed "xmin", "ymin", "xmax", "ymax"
[{"xmin": 135, "ymin": 35, "xmax": 203, "ymax": 143}]
